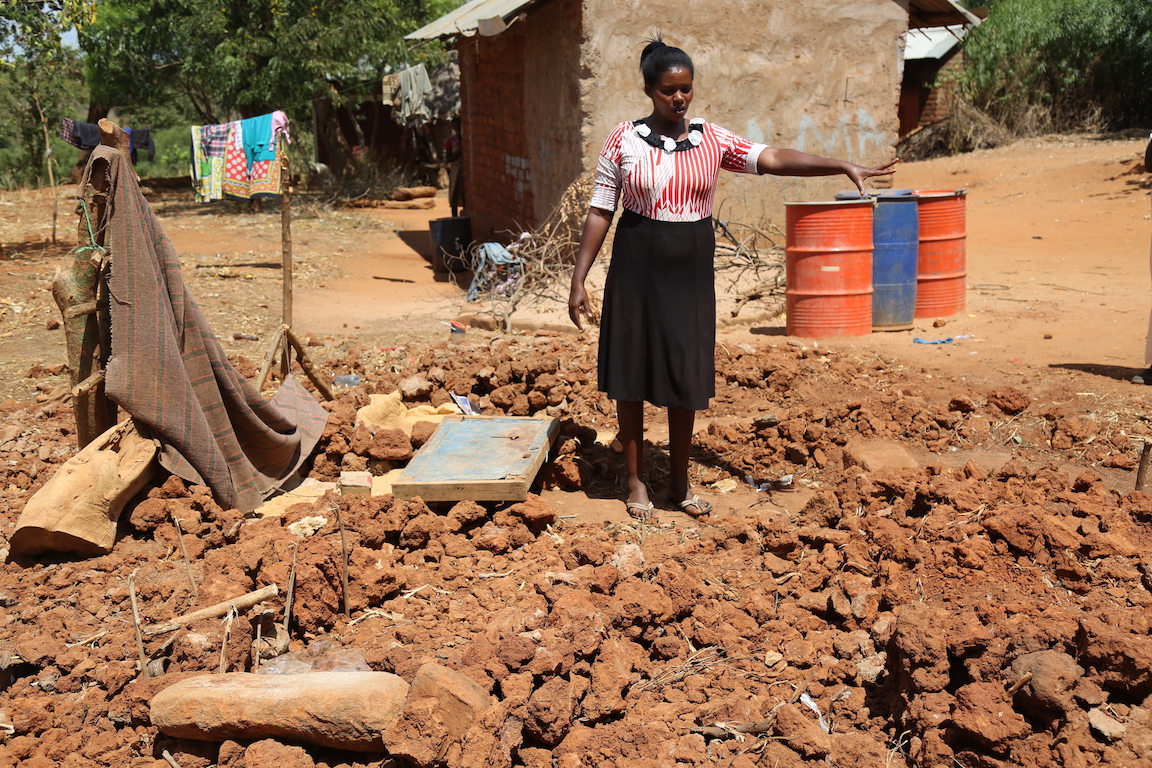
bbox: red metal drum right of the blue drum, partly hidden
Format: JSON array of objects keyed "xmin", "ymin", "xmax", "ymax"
[{"xmin": 916, "ymin": 189, "xmax": 968, "ymax": 318}]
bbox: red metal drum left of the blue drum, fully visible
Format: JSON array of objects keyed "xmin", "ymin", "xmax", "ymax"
[{"xmin": 785, "ymin": 199, "xmax": 874, "ymax": 339}]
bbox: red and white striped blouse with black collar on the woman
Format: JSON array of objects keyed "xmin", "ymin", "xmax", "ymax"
[{"xmin": 592, "ymin": 117, "xmax": 767, "ymax": 221}]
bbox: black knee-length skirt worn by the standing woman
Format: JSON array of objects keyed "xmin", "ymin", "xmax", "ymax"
[{"xmin": 598, "ymin": 210, "xmax": 717, "ymax": 411}]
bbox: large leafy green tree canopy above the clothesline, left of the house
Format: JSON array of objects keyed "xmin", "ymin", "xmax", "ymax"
[{"xmin": 79, "ymin": 0, "xmax": 458, "ymax": 123}]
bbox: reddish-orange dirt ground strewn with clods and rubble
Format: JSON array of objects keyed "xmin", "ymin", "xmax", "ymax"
[{"xmin": 0, "ymin": 136, "xmax": 1152, "ymax": 768}]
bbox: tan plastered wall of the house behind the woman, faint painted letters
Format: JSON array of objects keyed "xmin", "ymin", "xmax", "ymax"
[{"xmin": 581, "ymin": 0, "xmax": 908, "ymax": 226}]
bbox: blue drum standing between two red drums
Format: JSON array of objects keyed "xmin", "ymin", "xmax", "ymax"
[{"xmin": 836, "ymin": 189, "xmax": 920, "ymax": 330}]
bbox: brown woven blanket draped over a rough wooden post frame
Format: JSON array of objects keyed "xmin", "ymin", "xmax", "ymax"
[{"xmin": 81, "ymin": 146, "xmax": 328, "ymax": 512}]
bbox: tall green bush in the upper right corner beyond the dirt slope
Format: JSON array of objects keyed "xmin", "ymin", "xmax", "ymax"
[{"xmin": 961, "ymin": 0, "xmax": 1152, "ymax": 135}]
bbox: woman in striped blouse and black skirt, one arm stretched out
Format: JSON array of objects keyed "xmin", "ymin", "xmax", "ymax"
[{"xmin": 568, "ymin": 37, "xmax": 897, "ymax": 519}]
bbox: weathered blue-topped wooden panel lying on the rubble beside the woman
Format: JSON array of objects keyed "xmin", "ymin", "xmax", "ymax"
[{"xmin": 392, "ymin": 416, "xmax": 560, "ymax": 501}]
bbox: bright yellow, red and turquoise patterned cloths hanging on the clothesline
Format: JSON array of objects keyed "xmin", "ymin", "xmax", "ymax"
[{"xmin": 191, "ymin": 109, "xmax": 291, "ymax": 203}]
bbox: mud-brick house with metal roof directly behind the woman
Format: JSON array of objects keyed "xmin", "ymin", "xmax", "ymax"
[{"xmin": 409, "ymin": 0, "xmax": 979, "ymax": 237}]
